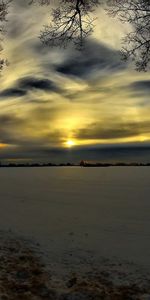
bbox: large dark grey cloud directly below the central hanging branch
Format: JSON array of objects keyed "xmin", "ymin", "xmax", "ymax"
[{"xmin": 56, "ymin": 41, "xmax": 125, "ymax": 78}]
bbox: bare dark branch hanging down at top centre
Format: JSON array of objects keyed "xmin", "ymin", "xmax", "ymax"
[{"xmin": 40, "ymin": 0, "xmax": 99, "ymax": 48}]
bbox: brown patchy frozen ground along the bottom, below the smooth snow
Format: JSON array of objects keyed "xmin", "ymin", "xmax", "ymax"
[{"xmin": 0, "ymin": 231, "xmax": 150, "ymax": 300}]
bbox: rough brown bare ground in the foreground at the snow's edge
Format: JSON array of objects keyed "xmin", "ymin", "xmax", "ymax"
[{"xmin": 0, "ymin": 234, "xmax": 150, "ymax": 300}]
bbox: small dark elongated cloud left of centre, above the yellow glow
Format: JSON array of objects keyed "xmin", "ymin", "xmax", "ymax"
[{"xmin": 18, "ymin": 77, "xmax": 60, "ymax": 92}]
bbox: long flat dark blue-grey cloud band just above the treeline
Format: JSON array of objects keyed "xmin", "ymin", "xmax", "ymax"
[{"xmin": 0, "ymin": 144, "xmax": 150, "ymax": 163}]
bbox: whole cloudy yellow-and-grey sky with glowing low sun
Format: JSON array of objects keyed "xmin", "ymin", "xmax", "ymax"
[{"xmin": 0, "ymin": 0, "xmax": 150, "ymax": 162}]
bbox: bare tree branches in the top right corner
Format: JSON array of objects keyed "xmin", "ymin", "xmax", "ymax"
[{"xmin": 108, "ymin": 0, "xmax": 150, "ymax": 71}]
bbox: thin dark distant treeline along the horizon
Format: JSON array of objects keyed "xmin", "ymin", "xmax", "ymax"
[{"xmin": 0, "ymin": 160, "xmax": 150, "ymax": 168}]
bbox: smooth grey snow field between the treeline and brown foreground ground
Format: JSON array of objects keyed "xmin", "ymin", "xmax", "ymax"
[{"xmin": 0, "ymin": 167, "xmax": 150, "ymax": 270}]
